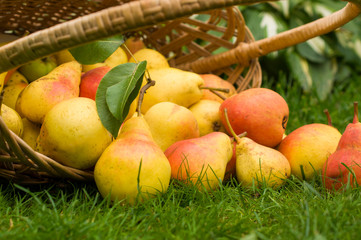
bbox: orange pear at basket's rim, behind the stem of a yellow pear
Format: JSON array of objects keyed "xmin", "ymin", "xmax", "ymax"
[{"xmin": 200, "ymin": 74, "xmax": 237, "ymax": 103}]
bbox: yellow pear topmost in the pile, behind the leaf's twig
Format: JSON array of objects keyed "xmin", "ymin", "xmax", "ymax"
[{"xmin": 129, "ymin": 48, "xmax": 169, "ymax": 70}]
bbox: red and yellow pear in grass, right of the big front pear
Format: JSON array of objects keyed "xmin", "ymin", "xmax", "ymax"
[{"xmin": 164, "ymin": 132, "xmax": 233, "ymax": 190}]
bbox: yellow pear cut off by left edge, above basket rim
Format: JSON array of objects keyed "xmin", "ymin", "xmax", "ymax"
[{"xmin": 1, "ymin": 104, "xmax": 24, "ymax": 137}]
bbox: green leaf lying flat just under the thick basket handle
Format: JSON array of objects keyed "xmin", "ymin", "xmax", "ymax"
[{"xmin": 69, "ymin": 35, "xmax": 124, "ymax": 65}]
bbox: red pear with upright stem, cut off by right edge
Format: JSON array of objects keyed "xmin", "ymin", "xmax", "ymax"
[{"xmin": 322, "ymin": 102, "xmax": 361, "ymax": 190}]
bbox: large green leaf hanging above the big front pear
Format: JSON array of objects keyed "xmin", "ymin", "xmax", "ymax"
[{"xmin": 95, "ymin": 61, "xmax": 146, "ymax": 138}]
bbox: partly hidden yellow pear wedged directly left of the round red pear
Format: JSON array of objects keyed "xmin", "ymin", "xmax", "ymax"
[{"xmin": 189, "ymin": 99, "xmax": 226, "ymax": 136}]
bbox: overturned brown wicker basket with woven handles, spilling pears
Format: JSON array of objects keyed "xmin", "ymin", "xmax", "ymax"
[{"xmin": 0, "ymin": 0, "xmax": 360, "ymax": 184}]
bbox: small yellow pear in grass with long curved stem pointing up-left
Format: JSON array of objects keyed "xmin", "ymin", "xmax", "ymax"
[{"xmin": 224, "ymin": 109, "xmax": 291, "ymax": 188}]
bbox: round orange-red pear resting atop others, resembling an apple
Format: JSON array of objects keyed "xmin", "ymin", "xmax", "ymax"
[{"xmin": 219, "ymin": 88, "xmax": 289, "ymax": 148}]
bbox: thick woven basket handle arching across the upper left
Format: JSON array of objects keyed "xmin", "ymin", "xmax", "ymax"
[{"xmin": 0, "ymin": 0, "xmax": 278, "ymax": 73}]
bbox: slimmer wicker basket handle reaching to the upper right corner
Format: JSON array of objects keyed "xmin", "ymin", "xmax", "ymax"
[{"xmin": 183, "ymin": 2, "xmax": 361, "ymax": 73}]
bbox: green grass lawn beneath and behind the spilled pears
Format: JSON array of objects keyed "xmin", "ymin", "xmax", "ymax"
[{"xmin": 0, "ymin": 73, "xmax": 361, "ymax": 240}]
